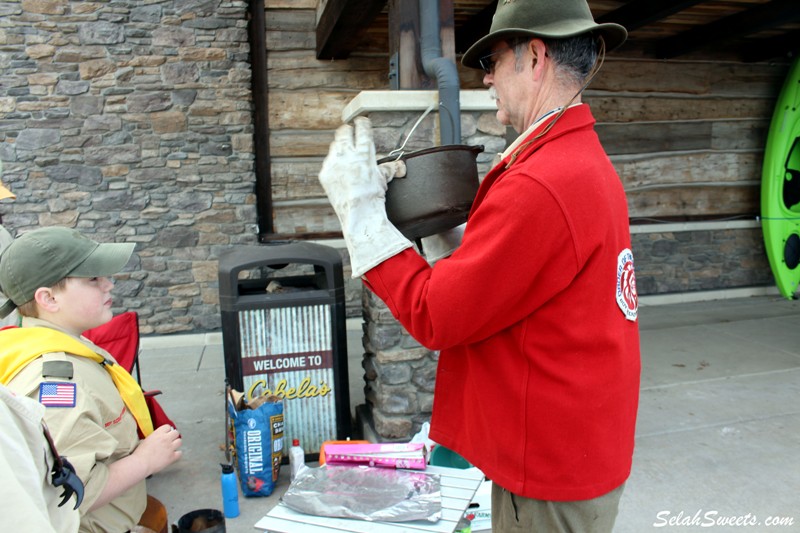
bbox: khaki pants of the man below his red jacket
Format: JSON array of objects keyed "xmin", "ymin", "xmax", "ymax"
[{"xmin": 492, "ymin": 483, "xmax": 625, "ymax": 533}]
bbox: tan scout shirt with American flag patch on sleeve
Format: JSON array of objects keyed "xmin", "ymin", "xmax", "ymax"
[{"xmin": 2, "ymin": 317, "xmax": 147, "ymax": 533}]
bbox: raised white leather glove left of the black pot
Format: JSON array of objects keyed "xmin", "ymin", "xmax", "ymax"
[{"xmin": 319, "ymin": 117, "xmax": 412, "ymax": 278}]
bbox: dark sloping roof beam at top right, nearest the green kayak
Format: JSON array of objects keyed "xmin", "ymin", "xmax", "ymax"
[{"xmin": 656, "ymin": 0, "xmax": 800, "ymax": 59}]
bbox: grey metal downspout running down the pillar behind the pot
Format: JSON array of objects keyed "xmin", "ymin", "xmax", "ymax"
[{"xmin": 419, "ymin": 0, "xmax": 461, "ymax": 145}]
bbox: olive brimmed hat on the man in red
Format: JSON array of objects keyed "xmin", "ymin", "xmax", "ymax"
[{"xmin": 461, "ymin": 0, "xmax": 628, "ymax": 68}]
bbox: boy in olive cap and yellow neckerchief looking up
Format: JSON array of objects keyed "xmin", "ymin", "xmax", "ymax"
[{"xmin": 0, "ymin": 227, "xmax": 181, "ymax": 532}]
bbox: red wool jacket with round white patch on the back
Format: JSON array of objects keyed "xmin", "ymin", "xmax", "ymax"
[{"xmin": 365, "ymin": 105, "xmax": 639, "ymax": 501}]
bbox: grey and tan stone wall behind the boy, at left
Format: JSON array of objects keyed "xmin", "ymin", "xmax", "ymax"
[{"xmin": 0, "ymin": 0, "xmax": 257, "ymax": 334}]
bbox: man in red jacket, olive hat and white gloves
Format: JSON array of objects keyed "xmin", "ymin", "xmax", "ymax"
[{"xmin": 320, "ymin": 0, "xmax": 640, "ymax": 533}]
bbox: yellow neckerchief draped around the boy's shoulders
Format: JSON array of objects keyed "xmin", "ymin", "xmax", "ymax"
[{"xmin": 0, "ymin": 327, "xmax": 153, "ymax": 437}]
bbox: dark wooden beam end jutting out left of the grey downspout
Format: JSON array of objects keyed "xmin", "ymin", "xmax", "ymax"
[{"xmin": 317, "ymin": 0, "xmax": 387, "ymax": 59}]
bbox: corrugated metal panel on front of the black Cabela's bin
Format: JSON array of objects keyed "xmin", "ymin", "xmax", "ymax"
[{"xmin": 239, "ymin": 305, "xmax": 336, "ymax": 453}]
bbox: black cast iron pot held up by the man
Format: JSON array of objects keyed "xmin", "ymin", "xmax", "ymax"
[{"xmin": 378, "ymin": 144, "xmax": 483, "ymax": 240}]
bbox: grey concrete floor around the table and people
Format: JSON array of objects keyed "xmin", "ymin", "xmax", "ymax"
[{"xmin": 140, "ymin": 296, "xmax": 800, "ymax": 533}]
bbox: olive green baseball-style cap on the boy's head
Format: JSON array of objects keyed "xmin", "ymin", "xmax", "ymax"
[{"xmin": 0, "ymin": 227, "xmax": 136, "ymax": 318}]
